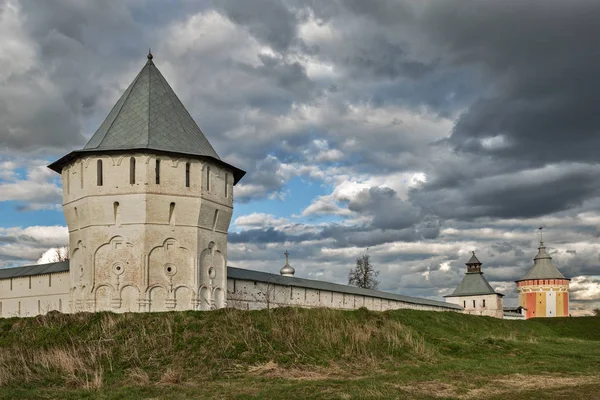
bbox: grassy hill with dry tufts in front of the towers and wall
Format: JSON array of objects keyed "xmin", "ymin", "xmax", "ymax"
[{"xmin": 0, "ymin": 308, "xmax": 600, "ymax": 399}]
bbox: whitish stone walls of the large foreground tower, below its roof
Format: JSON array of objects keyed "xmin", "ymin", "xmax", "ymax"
[{"xmin": 62, "ymin": 152, "xmax": 233, "ymax": 312}]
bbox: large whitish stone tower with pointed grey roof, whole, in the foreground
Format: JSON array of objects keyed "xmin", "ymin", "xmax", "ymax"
[{"xmin": 49, "ymin": 54, "xmax": 245, "ymax": 312}]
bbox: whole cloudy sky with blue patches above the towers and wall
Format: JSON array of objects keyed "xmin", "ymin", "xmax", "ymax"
[{"xmin": 0, "ymin": 0, "xmax": 600, "ymax": 309}]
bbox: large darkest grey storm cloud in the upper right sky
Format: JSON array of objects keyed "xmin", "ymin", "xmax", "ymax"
[{"xmin": 426, "ymin": 1, "xmax": 600, "ymax": 164}]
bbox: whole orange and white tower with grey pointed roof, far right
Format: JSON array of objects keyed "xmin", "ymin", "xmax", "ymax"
[{"xmin": 516, "ymin": 233, "xmax": 570, "ymax": 319}]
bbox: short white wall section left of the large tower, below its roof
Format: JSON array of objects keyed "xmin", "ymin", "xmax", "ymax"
[{"xmin": 0, "ymin": 272, "xmax": 70, "ymax": 318}]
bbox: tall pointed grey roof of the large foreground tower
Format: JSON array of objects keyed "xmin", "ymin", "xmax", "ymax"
[{"xmin": 84, "ymin": 55, "xmax": 219, "ymax": 159}]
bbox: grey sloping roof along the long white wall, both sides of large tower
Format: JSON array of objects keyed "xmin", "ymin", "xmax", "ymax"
[{"xmin": 0, "ymin": 261, "xmax": 462, "ymax": 310}]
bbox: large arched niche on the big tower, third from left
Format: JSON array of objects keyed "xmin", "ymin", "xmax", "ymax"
[{"xmin": 148, "ymin": 238, "xmax": 194, "ymax": 293}]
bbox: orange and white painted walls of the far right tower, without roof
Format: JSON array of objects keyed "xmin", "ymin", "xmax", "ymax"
[{"xmin": 517, "ymin": 279, "xmax": 569, "ymax": 319}]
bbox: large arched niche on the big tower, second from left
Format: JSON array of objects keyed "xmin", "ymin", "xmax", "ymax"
[{"xmin": 93, "ymin": 236, "xmax": 136, "ymax": 293}]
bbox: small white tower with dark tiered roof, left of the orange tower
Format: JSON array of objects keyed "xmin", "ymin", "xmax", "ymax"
[{"xmin": 444, "ymin": 251, "xmax": 504, "ymax": 318}]
